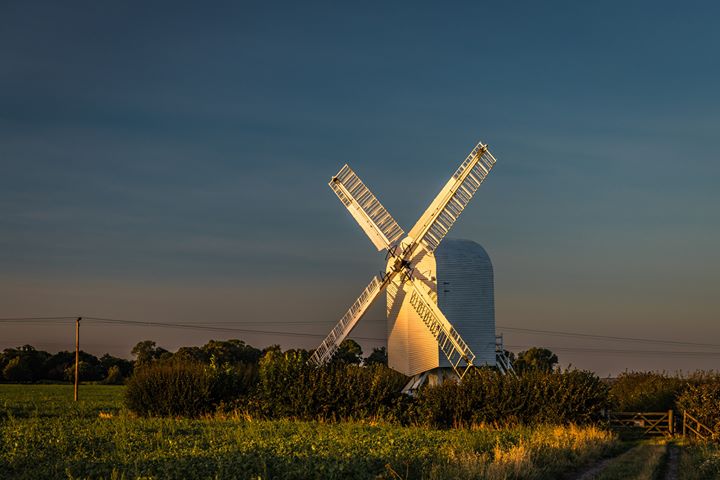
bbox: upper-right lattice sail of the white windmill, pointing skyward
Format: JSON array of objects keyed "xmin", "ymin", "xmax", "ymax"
[{"xmin": 408, "ymin": 142, "xmax": 495, "ymax": 253}]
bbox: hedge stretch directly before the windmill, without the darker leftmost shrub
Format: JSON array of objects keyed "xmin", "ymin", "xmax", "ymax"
[{"xmin": 247, "ymin": 351, "xmax": 609, "ymax": 427}]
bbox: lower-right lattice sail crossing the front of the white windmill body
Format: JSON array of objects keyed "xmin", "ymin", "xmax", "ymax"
[{"xmin": 410, "ymin": 280, "xmax": 475, "ymax": 378}]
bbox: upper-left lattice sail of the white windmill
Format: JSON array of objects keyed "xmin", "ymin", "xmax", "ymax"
[{"xmin": 329, "ymin": 165, "xmax": 405, "ymax": 250}]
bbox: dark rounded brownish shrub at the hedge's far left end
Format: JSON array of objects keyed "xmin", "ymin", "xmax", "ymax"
[{"xmin": 125, "ymin": 361, "xmax": 253, "ymax": 417}]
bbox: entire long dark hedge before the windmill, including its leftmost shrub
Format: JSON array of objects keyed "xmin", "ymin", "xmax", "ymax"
[{"xmin": 126, "ymin": 350, "xmax": 609, "ymax": 428}]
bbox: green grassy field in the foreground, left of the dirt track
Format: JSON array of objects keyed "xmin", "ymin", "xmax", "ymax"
[{"xmin": 0, "ymin": 385, "xmax": 618, "ymax": 479}]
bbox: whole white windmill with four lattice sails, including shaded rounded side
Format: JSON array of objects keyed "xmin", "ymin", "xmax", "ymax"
[{"xmin": 311, "ymin": 143, "xmax": 504, "ymax": 389}]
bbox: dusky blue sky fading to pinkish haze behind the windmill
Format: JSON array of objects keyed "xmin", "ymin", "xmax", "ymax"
[{"xmin": 0, "ymin": 1, "xmax": 720, "ymax": 374}]
